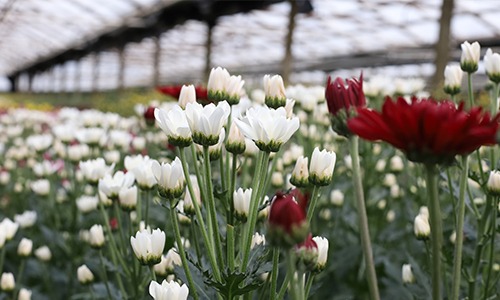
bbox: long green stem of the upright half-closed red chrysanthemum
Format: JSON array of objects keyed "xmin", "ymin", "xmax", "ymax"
[{"xmin": 349, "ymin": 136, "xmax": 380, "ymax": 300}]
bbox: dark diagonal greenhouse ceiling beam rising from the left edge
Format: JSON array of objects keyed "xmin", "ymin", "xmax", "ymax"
[{"xmin": 8, "ymin": 0, "xmax": 284, "ymax": 78}]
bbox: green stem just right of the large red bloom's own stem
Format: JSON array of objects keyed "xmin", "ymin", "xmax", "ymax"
[{"xmin": 451, "ymin": 155, "xmax": 469, "ymax": 299}]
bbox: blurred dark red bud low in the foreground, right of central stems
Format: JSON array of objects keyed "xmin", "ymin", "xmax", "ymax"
[{"xmin": 267, "ymin": 190, "xmax": 309, "ymax": 248}]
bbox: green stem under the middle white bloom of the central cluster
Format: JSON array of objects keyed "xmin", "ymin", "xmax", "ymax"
[{"xmin": 203, "ymin": 146, "xmax": 224, "ymax": 267}]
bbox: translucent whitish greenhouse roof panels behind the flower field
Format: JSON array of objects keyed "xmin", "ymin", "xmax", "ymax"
[{"xmin": 0, "ymin": 0, "xmax": 500, "ymax": 90}]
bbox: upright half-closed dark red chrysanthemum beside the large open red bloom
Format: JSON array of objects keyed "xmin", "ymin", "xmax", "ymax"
[{"xmin": 325, "ymin": 74, "xmax": 366, "ymax": 137}]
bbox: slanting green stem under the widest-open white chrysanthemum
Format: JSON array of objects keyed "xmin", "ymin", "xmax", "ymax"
[{"xmin": 241, "ymin": 151, "xmax": 269, "ymax": 272}]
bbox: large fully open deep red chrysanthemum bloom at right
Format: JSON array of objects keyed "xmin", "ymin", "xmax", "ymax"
[{"xmin": 348, "ymin": 97, "xmax": 500, "ymax": 164}]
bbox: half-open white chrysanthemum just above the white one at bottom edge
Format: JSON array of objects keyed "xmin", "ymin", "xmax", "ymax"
[{"xmin": 130, "ymin": 229, "xmax": 165, "ymax": 266}]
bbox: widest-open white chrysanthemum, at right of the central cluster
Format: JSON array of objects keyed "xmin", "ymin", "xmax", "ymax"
[{"xmin": 235, "ymin": 106, "xmax": 300, "ymax": 152}]
